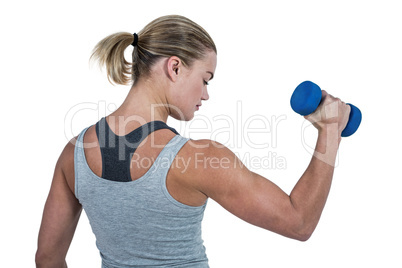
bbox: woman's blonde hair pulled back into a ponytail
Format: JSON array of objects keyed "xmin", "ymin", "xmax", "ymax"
[{"xmin": 91, "ymin": 15, "xmax": 217, "ymax": 85}]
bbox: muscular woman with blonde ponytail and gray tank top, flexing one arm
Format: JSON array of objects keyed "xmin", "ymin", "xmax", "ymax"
[{"xmin": 36, "ymin": 16, "xmax": 349, "ymax": 267}]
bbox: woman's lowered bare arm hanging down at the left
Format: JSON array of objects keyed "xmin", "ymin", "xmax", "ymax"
[{"xmin": 36, "ymin": 139, "xmax": 82, "ymax": 267}]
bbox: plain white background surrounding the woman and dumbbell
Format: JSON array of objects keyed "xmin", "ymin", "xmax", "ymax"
[{"xmin": 0, "ymin": 0, "xmax": 402, "ymax": 267}]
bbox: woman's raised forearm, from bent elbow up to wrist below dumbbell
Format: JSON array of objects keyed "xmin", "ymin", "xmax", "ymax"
[{"xmin": 290, "ymin": 127, "xmax": 340, "ymax": 237}]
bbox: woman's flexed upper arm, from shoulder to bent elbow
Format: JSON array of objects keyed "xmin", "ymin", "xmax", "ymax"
[{"xmin": 186, "ymin": 140, "xmax": 302, "ymax": 239}]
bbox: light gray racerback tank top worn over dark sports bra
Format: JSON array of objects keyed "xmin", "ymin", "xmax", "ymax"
[{"xmin": 74, "ymin": 124, "xmax": 209, "ymax": 268}]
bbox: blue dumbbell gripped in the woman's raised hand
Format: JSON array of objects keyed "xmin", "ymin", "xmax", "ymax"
[{"xmin": 290, "ymin": 81, "xmax": 362, "ymax": 137}]
